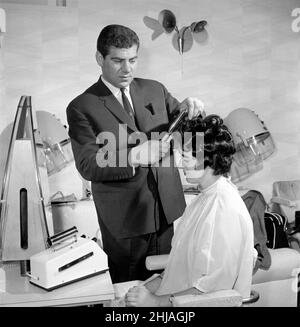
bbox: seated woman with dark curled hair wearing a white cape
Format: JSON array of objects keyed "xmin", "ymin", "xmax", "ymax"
[{"xmin": 125, "ymin": 115, "xmax": 255, "ymax": 307}]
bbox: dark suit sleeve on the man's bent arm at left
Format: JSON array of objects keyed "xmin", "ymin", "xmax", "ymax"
[{"xmin": 67, "ymin": 103, "xmax": 134, "ymax": 182}]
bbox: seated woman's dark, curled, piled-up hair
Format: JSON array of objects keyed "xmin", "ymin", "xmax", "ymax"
[{"xmin": 181, "ymin": 115, "xmax": 236, "ymax": 176}]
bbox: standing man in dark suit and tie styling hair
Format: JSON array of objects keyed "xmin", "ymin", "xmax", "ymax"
[{"xmin": 67, "ymin": 25, "xmax": 203, "ymax": 283}]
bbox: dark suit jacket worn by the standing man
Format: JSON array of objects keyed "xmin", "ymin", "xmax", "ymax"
[{"xmin": 67, "ymin": 78, "xmax": 185, "ymax": 238}]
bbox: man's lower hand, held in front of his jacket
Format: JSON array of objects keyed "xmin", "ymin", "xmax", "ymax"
[{"xmin": 129, "ymin": 139, "xmax": 170, "ymax": 167}]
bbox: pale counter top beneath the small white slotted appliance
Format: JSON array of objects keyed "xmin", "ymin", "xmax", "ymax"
[{"xmin": 0, "ymin": 263, "xmax": 115, "ymax": 307}]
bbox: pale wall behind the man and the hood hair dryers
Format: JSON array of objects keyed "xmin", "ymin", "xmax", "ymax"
[{"xmin": 0, "ymin": 0, "xmax": 300, "ymax": 200}]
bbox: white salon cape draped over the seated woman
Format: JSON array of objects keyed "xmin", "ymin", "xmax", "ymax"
[{"xmin": 156, "ymin": 176, "xmax": 256, "ymax": 298}]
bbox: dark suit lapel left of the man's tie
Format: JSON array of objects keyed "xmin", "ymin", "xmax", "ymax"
[{"xmin": 98, "ymin": 78, "xmax": 137, "ymax": 131}]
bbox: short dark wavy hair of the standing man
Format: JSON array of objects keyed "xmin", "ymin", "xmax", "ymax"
[{"xmin": 97, "ymin": 25, "xmax": 140, "ymax": 58}]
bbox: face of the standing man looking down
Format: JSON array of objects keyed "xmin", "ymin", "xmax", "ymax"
[{"xmin": 96, "ymin": 45, "xmax": 138, "ymax": 88}]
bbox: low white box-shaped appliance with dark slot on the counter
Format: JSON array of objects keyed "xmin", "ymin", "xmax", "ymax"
[{"xmin": 27, "ymin": 226, "xmax": 108, "ymax": 291}]
